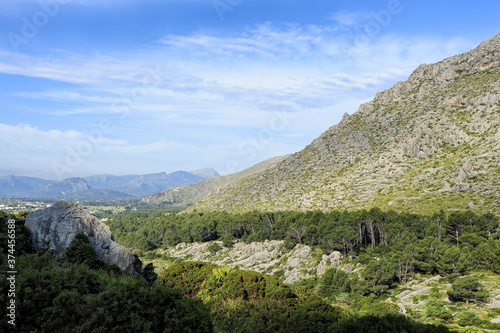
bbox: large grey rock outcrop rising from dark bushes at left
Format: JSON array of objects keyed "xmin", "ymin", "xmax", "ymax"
[{"xmin": 26, "ymin": 201, "xmax": 138, "ymax": 275}]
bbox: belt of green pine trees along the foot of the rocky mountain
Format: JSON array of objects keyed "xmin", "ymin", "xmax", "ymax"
[{"xmin": 107, "ymin": 208, "xmax": 500, "ymax": 278}]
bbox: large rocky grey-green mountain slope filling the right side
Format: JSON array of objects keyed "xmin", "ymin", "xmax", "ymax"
[{"xmin": 191, "ymin": 34, "xmax": 500, "ymax": 214}]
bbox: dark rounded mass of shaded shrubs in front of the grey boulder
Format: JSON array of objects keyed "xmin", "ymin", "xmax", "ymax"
[{"xmin": 0, "ymin": 255, "xmax": 212, "ymax": 333}]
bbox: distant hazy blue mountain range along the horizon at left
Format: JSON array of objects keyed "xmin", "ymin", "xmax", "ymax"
[{"xmin": 0, "ymin": 168, "xmax": 219, "ymax": 200}]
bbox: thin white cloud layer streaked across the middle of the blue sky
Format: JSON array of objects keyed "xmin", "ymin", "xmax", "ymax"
[{"xmin": 0, "ymin": 17, "xmax": 474, "ymax": 174}]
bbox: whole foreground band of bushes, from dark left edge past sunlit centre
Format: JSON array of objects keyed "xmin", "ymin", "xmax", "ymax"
[{"xmin": 0, "ymin": 212, "xmax": 460, "ymax": 333}]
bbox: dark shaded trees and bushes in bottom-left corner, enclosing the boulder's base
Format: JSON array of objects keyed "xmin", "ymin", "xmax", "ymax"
[{"xmin": 0, "ymin": 211, "xmax": 212, "ymax": 333}]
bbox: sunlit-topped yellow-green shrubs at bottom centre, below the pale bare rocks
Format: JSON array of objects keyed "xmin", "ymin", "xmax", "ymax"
[{"xmin": 160, "ymin": 262, "xmax": 340, "ymax": 333}]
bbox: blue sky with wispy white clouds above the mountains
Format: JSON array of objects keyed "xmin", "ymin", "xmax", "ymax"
[{"xmin": 0, "ymin": 0, "xmax": 500, "ymax": 180}]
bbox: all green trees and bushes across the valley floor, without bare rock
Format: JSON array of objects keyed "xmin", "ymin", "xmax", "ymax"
[{"xmin": 0, "ymin": 209, "xmax": 500, "ymax": 333}]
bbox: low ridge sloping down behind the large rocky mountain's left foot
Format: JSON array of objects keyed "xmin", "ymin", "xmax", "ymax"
[{"xmin": 140, "ymin": 155, "xmax": 288, "ymax": 207}]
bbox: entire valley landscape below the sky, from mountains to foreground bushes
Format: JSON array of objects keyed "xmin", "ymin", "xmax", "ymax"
[{"xmin": 0, "ymin": 27, "xmax": 500, "ymax": 333}]
